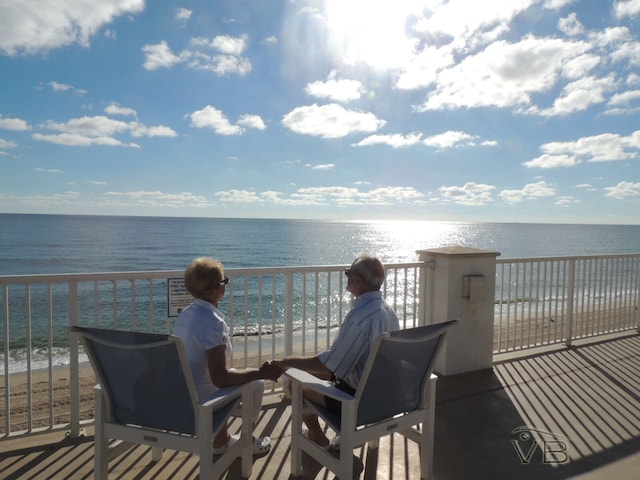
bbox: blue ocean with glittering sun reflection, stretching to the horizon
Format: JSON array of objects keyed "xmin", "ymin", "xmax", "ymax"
[{"xmin": 0, "ymin": 214, "xmax": 640, "ymax": 372}]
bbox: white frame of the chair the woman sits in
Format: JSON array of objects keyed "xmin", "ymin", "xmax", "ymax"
[{"xmin": 71, "ymin": 327, "xmax": 253, "ymax": 480}]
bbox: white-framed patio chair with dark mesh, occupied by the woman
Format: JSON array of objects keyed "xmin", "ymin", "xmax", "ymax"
[{"xmin": 71, "ymin": 327, "xmax": 253, "ymax": 480}]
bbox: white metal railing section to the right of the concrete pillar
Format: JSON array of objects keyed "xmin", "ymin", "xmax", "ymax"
[{"xmin": 494, "ymin": 255, "xmax": 640, "ymax": 353}]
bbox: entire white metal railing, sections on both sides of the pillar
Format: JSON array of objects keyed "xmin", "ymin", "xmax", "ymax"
[{"xmin": 0, "ymin": 255, "xmax": 640, "ymax": 440}]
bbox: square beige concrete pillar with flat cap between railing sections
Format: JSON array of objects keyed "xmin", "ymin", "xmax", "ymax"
[{"xmin": 417, "ymin": 247, "xmax": 500, "ymax": 375}]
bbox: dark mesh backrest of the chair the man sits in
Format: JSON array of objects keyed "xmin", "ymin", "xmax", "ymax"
[{"xmin": 355, "ymin": 320, "xmax": 457, "ymax": 425}]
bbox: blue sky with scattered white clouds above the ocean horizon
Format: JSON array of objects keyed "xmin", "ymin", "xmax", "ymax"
[{"xmin": 0, "ymin": 0, "xmax": 640, "ymax": 224}]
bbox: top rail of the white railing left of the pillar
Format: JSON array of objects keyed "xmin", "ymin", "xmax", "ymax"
[{"xmin": 0, "ymin": 262, "xmax": 429, "ymax": 286}]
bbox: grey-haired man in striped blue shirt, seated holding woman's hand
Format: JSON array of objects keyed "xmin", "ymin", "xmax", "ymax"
[{"xmin": 273, "ymin": 255, "xmax": 400, "ymax": 449}]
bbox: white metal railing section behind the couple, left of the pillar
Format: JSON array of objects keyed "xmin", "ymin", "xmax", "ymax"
[{"xmin": 0, "ymin": 262, "xmax": 429, "ymax": 440}]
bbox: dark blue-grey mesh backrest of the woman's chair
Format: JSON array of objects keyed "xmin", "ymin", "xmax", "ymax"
[{"xmin": 72, "ymin": 327, "xmax": 197, "ymax": 435}]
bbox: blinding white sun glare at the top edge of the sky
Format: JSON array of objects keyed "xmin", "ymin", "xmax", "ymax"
[{"xmin": 325, "ymin": 0, "xmax": 414, "ymax": 69}]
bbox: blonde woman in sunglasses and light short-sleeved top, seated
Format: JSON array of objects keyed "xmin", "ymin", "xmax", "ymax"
[{"xmin": 174, "ymin": 257, "xmax": 282, "ymax": 455}]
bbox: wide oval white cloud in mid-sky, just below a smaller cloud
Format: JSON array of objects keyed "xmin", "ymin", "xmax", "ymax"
[{"xmin": 282, "ymin": 103, "xmax": 386, "ymax": 138}]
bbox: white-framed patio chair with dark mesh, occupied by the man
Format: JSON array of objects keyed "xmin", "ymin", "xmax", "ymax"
[{"xmin": 286, "ymin": 320, "xmax": 457, "ymax": 480}]
